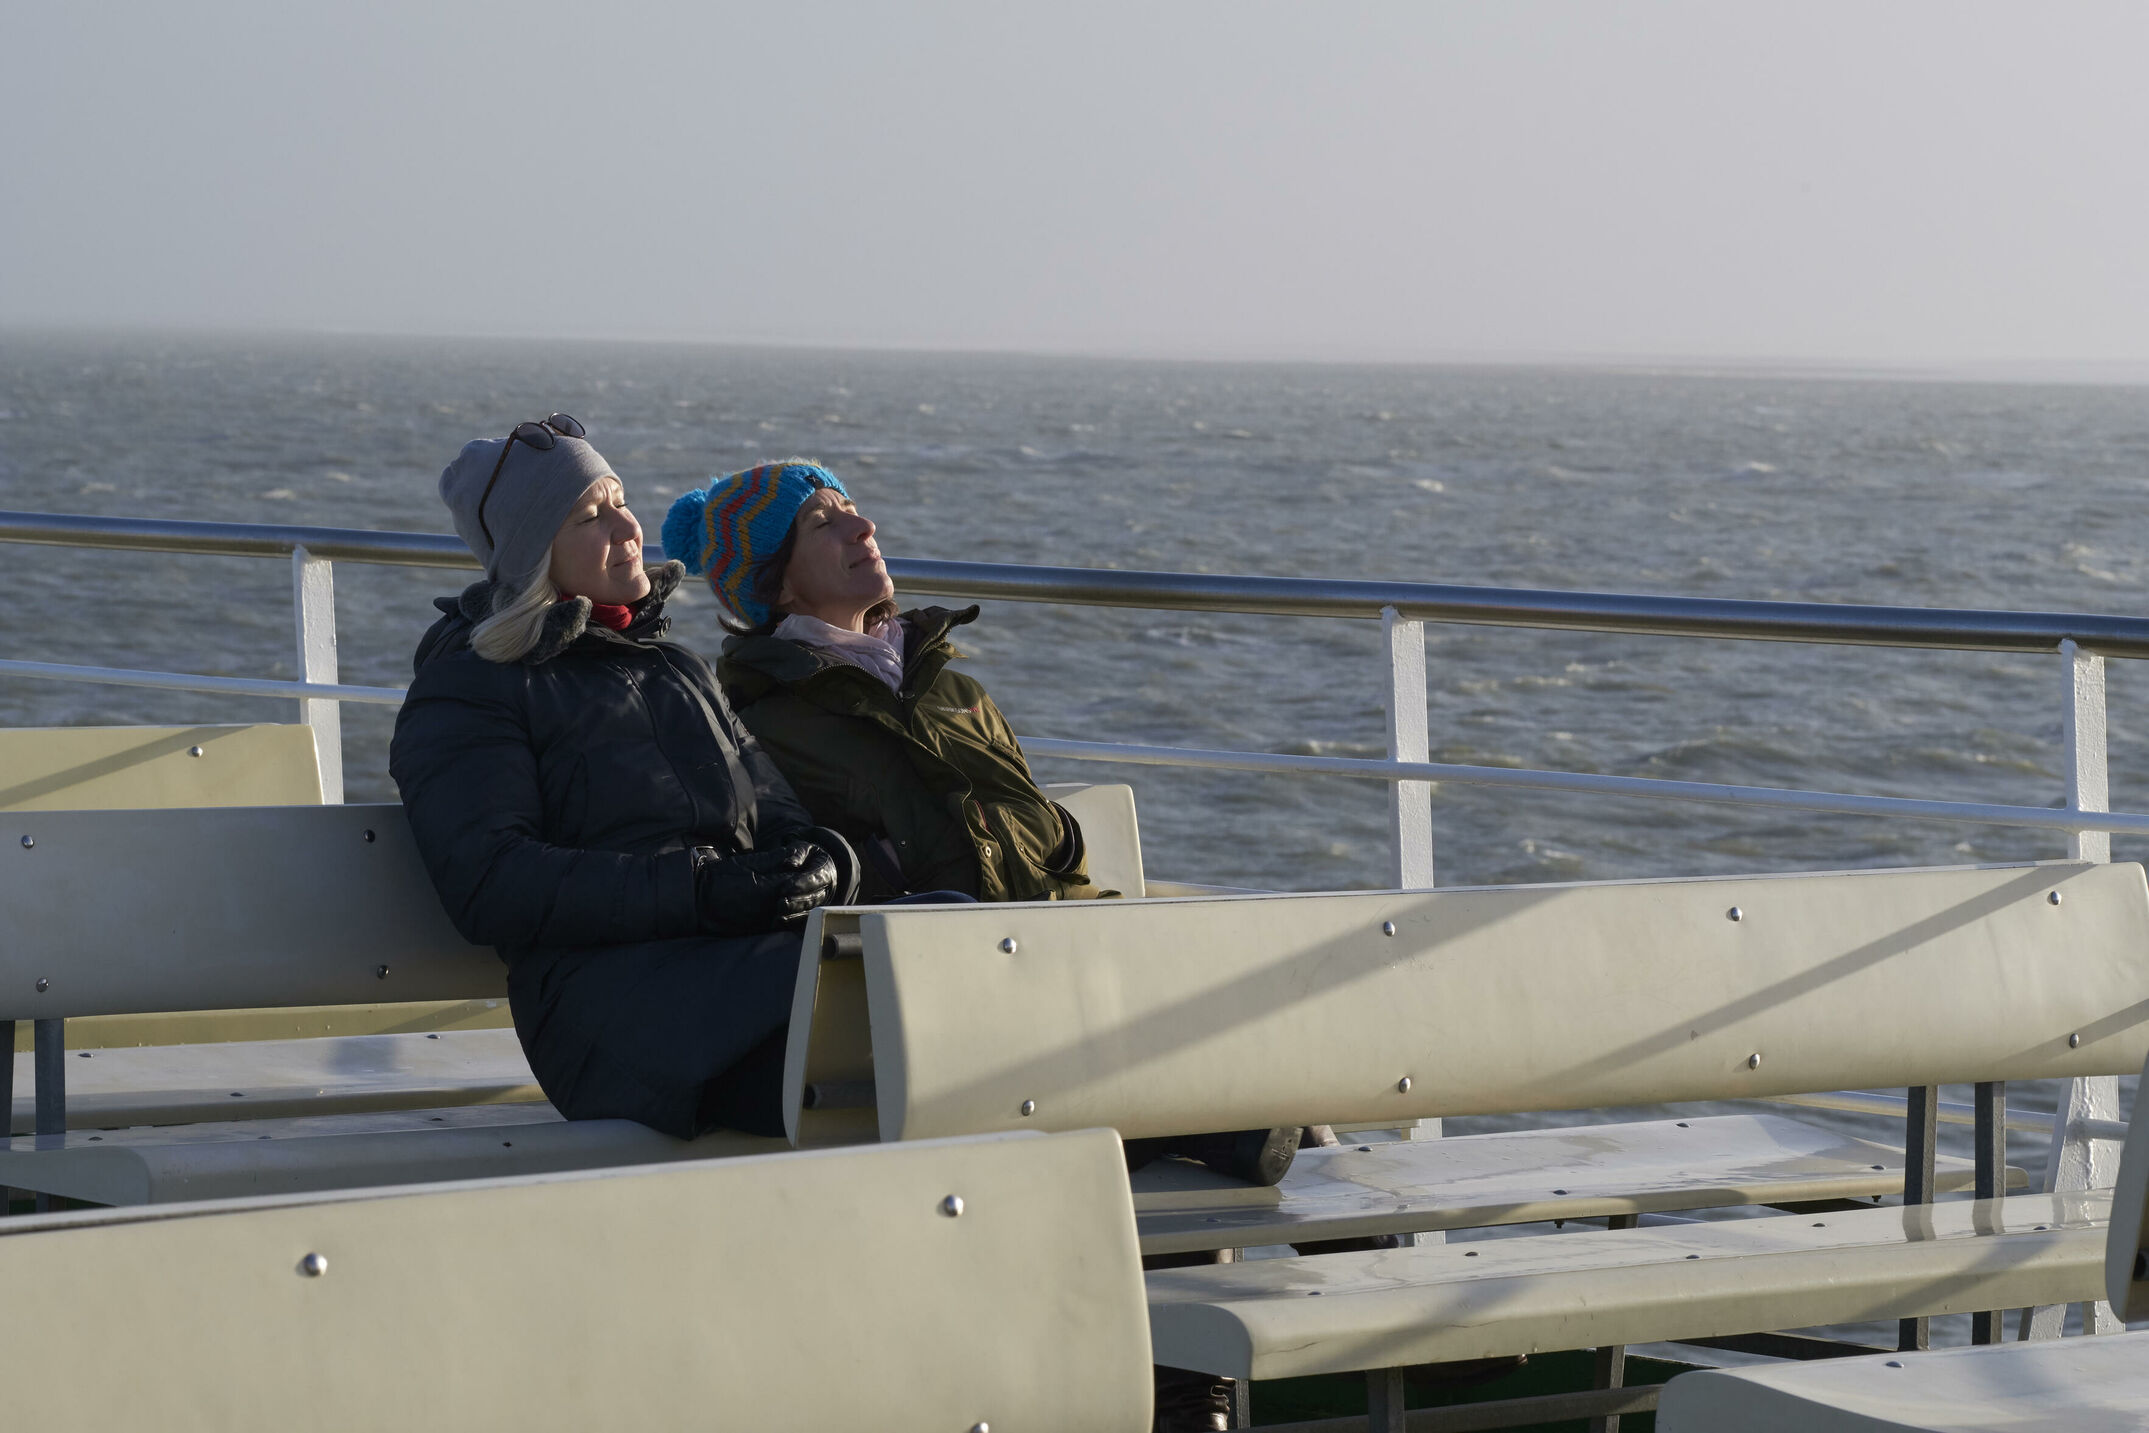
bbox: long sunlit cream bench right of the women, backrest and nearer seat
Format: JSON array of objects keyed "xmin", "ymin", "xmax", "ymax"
[{"xmin": 787, "ymin": 864, "xmax": 2149, "ymax": 1427}]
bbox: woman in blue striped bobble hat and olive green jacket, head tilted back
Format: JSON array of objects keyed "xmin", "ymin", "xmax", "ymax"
[{"xmin": 664, "ymin": 458, "xmax": 1094, "ymax": 900}]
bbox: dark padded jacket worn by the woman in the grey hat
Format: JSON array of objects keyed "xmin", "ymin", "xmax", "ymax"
[{"xmin": 389, "ymin": 563, "xmax": 812, "ymax": 965}]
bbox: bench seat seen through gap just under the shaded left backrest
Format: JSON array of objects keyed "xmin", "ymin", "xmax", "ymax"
[{"xmin": 11, "ymin": 1029, "xmax": 544, "ymax": 1134}]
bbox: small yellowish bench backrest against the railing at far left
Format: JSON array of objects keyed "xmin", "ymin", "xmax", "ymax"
[{"xmin": 0, "ymin": 722, "xmax": 320, "ymax": 810}]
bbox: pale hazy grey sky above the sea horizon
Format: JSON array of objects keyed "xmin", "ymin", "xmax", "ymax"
[{"xmin": 0, "ymin": 0, "xmax": 2149, "ymax": 361}]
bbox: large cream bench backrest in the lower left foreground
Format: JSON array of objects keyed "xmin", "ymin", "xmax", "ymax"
[{"xmin": 0, "ymin": 1130, "xmax": 1152, "ymax": 1433}]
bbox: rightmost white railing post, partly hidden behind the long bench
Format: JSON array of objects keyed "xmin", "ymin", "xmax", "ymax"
[{"xmin": 2020, "ymin": 642, "xmax": 2121, "ymax": 1338}]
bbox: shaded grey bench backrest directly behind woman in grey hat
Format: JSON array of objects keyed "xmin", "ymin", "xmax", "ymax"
[{"xmin": 0, "ymin": 806, "xmax": 492, "ymax": 1021}]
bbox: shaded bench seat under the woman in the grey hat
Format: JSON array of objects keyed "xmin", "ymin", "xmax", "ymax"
[{"xmin": 0, "ymin": 1104, "xmax": 789, "ymax": 1205}]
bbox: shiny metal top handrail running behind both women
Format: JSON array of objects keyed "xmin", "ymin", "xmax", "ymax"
[{"xmin": 0, "ymin": 511, "xmax": 2149, "ymax": 657}]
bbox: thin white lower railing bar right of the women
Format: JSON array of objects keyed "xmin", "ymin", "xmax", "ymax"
[{"xmin": 1023, "ymin": 737, "xmax": 2149, "ymax": 836}]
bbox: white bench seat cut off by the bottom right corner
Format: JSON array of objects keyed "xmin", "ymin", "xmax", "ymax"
[{"xmin": 1657, "ymin": 1332, "xmax": 2149, "ymax": 1433}]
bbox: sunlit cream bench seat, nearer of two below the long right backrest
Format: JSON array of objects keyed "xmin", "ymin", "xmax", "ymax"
[{"xmin": 1148, "ymin": 1192, "xmax": 2112, "ymax": 1379}]
